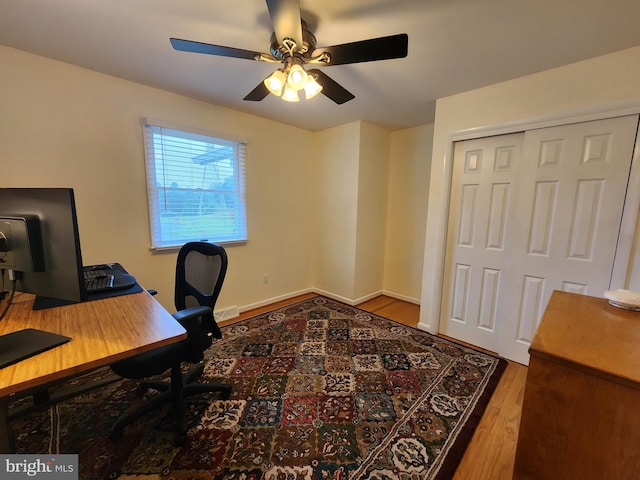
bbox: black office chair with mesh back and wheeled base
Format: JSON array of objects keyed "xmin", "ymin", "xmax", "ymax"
[{"xmin": 109, "ymin": 242, "xmax": 231, "ymax": 444}]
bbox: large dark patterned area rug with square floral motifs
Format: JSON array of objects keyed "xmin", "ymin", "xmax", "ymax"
[{"xmin": 12, "ymin": 296, "xmax": 506, "ymax": 480}]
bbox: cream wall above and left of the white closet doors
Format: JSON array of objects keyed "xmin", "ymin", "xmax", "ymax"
[{"xmin": 420, "ymin": 47, "xmax": 640, "ymax": 332}]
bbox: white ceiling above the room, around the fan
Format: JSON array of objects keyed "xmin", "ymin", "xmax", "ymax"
[{"xmin": 0, "ymin": 0, "xmax": 640, "ymax": 131}]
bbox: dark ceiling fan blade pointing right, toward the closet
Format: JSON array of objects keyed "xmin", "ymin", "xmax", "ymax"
[{"xmin": 312, "ymin": 33, "xmax": 409, "ymax": 65}]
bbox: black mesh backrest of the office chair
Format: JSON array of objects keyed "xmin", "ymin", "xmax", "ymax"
[{"xmin": 174, "ymin": 242, "xmax": 227, "ymax": 310}]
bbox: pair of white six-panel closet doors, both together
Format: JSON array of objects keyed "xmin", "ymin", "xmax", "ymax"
[{"xmin": 440, "ymin": 115, "xmax": 638, "ymax": 364}]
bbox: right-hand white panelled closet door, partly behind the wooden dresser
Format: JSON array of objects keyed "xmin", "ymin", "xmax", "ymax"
[{"xmin": 500, "ymin": 115, "xmax": 638, "ymax": 364}]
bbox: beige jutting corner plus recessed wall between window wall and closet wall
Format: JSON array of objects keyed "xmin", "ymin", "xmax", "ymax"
[{"xmin": 312, "ymin": 122, "xmax": 433, "ymax": 303}]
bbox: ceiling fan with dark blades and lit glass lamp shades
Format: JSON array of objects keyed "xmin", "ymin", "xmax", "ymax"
[{"xmin": 170, "ymin": 0, "xmax": 409, "ymax": 105}]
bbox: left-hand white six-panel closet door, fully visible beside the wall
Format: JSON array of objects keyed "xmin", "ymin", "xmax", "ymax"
[{"xmin": 440, "ymin": 133, "xmax": 524, "ymax": 352}]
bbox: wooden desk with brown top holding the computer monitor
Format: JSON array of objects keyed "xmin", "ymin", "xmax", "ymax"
[{"xmin": 0, "ymin": 291, "xmax": 187, "ymax": 452}]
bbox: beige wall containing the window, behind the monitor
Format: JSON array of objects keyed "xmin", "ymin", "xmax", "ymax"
[{"xmin": 0, "ymin": 46, "xmax": 314, "ymax": 309}]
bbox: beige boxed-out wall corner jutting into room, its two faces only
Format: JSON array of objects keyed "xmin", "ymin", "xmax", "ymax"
[{"xmin": 312, "ymin": 122, "xmax": 390, "ymax": 304}]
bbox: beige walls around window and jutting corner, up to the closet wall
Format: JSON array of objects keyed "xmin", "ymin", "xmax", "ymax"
[{"xmin": 0, "ymin": 46, "xmax": 431, "ymax": 316}]
